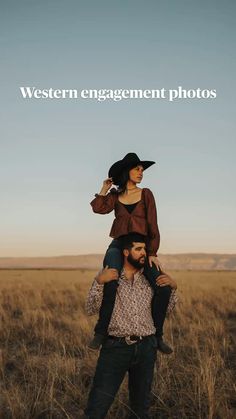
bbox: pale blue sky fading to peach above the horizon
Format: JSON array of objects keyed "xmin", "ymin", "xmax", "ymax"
[{"xmin": 0, "ymin": 0, "xmax": 236, "ymax": 257}]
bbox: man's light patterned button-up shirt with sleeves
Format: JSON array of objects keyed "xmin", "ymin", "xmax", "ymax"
[{"xmin": 86, "ymin": 270, "xmax": 177, "ymax": 336}]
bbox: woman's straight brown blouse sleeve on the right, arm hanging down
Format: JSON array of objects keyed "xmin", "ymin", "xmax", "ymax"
[{"xmin": 145, "ymin": 189, "xmax": 160, "ymax": 256}]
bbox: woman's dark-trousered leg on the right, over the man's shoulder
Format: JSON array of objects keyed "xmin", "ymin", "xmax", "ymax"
[{"xmin": 144, "ymin": 262, "xmax": 172, "ymax": 353}]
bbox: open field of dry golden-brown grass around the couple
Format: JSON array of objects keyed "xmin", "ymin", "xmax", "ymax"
[{"xmin": 0, "ymin": 270, "xmax": 236, "ymax": 419}]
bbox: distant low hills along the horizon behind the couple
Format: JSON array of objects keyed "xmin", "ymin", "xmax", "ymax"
[{"xmin": 0, "ymin": 253, "xmax": 236, "ymax": 271}]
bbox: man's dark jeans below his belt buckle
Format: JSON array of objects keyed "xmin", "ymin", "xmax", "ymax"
[{"xmin": 85, "ymin": 335, "xmax": 157, "ymax": 419}]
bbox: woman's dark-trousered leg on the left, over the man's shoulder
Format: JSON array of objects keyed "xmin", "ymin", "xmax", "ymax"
[{"xmin": 94, "ymin": 239, "xmax": 123, "ymax": 336}]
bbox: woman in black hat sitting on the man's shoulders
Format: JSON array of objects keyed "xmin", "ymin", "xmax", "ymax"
[{"xmin": 89, "ymin": 153, "xmax": 176, "ymax": 354}]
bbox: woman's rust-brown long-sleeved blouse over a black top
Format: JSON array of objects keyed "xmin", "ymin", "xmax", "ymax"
[{"xmin": 90, "ymin": 188, "xmax": 160, "ymax": 256}]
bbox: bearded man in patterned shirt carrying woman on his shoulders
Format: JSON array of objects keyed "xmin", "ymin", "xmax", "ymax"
[{"xmin": 85, "ymin": 233, "xmax": 177, "ymax": 419}]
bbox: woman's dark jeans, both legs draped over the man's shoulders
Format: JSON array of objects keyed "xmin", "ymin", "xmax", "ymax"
[{"xmin": 94, "ymin": 239, "xmax": 171, "ymax": 336}]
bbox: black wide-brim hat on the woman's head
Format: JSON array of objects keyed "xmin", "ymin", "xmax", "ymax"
[{"xmin": 108, "ymin": 153, "xmax": 155, "ymax": 185}]
